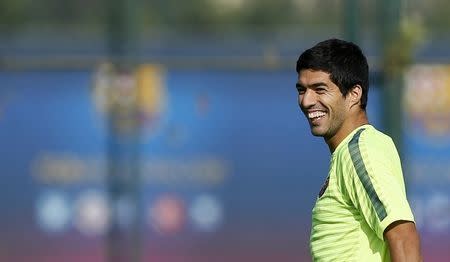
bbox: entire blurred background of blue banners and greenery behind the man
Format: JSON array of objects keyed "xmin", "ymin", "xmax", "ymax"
[{"xmin": 0, "ymin": 0, "xmax": 450, "ymax": 262}]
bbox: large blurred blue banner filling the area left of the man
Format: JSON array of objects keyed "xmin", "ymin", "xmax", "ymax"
[{"xmin": 0, "ymin": 68, "xmax": 329, "ymax": 262}]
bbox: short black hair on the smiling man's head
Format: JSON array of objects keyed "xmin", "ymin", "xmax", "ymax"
[{"xmin": 296, "ymin": 39, "xmax": 369, "ymax": 110}]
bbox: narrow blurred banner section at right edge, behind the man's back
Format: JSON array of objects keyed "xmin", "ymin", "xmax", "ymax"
[{"xmin": 404, "ymin": 65, "xmax": 450, "ymax": 261}]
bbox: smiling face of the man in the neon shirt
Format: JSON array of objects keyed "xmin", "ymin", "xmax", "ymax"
[{"xmin": 297, "ymin": 69, "xmax": 350, "ymax": 139}]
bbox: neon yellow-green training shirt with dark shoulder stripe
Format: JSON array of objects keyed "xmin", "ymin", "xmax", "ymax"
[{"xmin": 310, "ymin": 125, "xmax": 414, "ymax": 261}]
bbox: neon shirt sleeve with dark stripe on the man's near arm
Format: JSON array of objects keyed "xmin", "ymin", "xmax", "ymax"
[{"xmin": 345, "ymin": 132, "xmax": 414, "ymax": 240}]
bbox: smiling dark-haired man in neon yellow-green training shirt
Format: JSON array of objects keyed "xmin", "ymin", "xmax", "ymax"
[{"xmin": 296, "ymin": 39, "xmax": 422, "ymax": 261}]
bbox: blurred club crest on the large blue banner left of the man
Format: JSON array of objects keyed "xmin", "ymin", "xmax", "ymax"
[{"xmin": 93, "ymin": 63, "xmax": 167, "ymax": 138}]
